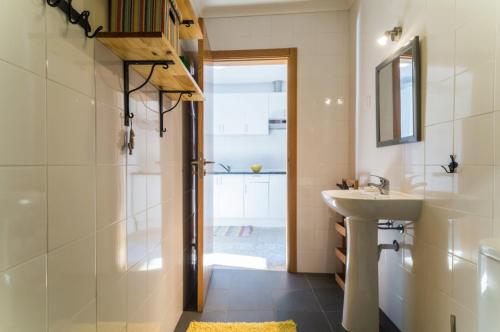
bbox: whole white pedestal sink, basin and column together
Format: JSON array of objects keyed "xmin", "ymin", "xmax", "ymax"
[{"xmin": 321, "ymin": 190, "xmax": 422, "ymax": 332}]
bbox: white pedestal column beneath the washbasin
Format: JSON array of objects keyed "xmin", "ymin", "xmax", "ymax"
[{"xmin": 342, "ymin": 217, "xmax": 379, "ymax": 332}]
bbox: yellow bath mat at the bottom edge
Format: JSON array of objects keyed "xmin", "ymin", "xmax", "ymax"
[{"xmin": 187, "ymin": 320, "xmax": 297, "ymax": 332}]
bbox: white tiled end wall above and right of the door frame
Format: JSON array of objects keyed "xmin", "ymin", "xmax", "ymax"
[{"xmin": 206, "ymin": 11, "xmax": 352, "ymax": 272}]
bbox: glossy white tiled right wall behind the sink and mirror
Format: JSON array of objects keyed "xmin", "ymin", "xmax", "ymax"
[{"xmin": 350, "ymin": 0, "xmax": 500, "ymax": 332}]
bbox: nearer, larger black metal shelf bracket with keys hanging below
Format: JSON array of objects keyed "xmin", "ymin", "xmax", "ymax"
[{"xmin": 123, "ymin": 60, "xmax": 174, "ymax": 127}]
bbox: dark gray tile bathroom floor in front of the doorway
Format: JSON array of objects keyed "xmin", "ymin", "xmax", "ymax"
[{"xmin": 175, "ymin": 269, "xmax": 398, "ymax": 332}]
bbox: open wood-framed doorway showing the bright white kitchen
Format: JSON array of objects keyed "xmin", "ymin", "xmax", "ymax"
[{"xmin": 204, "ymin": 49, "xmax": 296, "ymax": 271}]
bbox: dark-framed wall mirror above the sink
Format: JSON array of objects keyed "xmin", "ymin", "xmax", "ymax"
[{"xmin": 376, "ymin": 37, "xmax": 421, "ymax": 147}]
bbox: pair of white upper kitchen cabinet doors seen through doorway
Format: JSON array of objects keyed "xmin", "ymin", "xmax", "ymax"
[{"xmin": 214, "ymin": 93, "xmax": 269, "ymax": 136}]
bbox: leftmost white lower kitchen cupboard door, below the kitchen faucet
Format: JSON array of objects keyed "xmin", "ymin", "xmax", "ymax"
[{"xmin": 217, "ymin": 175, "xmax": 244, "ymax": 218}]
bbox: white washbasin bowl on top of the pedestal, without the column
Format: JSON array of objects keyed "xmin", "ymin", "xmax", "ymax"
[{"xmin": 321, "ymin": 190, "xmax": 422, "ymax": 220}]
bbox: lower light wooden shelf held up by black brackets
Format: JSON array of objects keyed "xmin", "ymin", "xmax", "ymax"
[{"xmin": 97, "ymin": 32, "xmax": 204, "ymax": 101}]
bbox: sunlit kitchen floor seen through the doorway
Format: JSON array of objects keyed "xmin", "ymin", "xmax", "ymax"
[{"xmin": 214, "ymin": 226, "xmax": 286, "ymax": 271}]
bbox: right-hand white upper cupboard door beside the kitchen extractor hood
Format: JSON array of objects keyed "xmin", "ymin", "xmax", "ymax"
[{"xmin": 244, "ymin": 93, "xmax": 269, "ymax": 135}]
